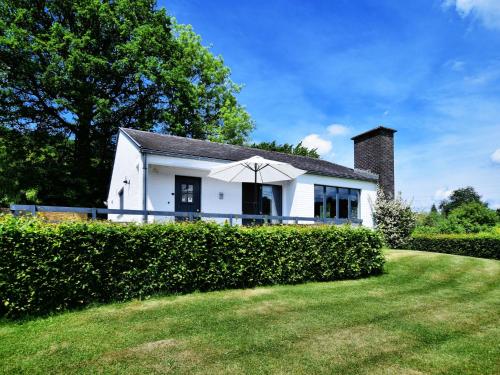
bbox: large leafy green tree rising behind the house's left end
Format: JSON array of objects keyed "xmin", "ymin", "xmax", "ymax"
[{"xmin": 0, "ymin": 0, "xmax": 253, "ymax": 205}]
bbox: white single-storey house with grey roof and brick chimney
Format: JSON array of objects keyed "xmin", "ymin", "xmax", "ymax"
[{"xmin": 107, "ymin": 127, "xmax": 395, "ymax": 227}]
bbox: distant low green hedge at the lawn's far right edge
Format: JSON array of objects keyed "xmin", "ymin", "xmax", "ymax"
[{"xmin": 409, "ymin": 233, "xmax": 500, "ymax": 259}]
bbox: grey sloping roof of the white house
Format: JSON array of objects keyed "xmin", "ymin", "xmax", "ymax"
[{"xmin": 121, "ymin": 128, "xmax": 378, "ymax": 182}]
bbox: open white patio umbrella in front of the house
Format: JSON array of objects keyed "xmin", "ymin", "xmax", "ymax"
[{"xmin": 208, "ymin": 156, "xmax": 306, "ymax": 211}]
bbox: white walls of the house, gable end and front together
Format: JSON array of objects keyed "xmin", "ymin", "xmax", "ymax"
[{"xmin": 108, "ymin": 148, "xmax": 376, "ymax": 227}]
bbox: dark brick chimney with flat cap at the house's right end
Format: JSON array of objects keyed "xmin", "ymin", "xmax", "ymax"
[{"xmin": 351, "ymin": 126, "xmax": 396, "ymax": 198}]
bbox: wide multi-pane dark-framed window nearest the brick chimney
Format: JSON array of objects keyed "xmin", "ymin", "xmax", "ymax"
[{"xmin": 314, "ymin": 185, "xmax": 359, "ymax": 220}]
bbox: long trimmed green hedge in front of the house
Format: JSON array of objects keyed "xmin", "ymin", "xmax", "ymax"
[{"xmin": 0, "ymin": 216, "xmax": 384, "ymax": 317}]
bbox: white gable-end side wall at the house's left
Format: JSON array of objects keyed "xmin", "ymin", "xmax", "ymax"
[{"xmin": 107, "ymin": 132, "xmax": 143, "ymax": 221}]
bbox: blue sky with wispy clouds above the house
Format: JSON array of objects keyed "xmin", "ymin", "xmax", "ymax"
[{"xmin": 159, "ymin": 0, "xmax": 500, "ymax": 209}]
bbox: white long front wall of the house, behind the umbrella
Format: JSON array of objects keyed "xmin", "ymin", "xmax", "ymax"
[{"xmin": 143, "ymin": 155, "xmax": 376, "ymax": 227}]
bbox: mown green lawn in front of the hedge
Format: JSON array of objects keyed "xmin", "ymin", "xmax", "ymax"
[{"xmin": 0, "ymin": 251, "xmax": 500, "ymax": 374}]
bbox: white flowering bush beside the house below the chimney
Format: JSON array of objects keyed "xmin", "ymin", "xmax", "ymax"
[{"xmin": 372, "ymin": 188, "xmax": 417, "ymax": 249}]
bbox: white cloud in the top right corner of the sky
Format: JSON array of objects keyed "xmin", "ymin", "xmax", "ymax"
[{"xmin": 443, "ymin": 0, "xmax": 500, "ymax": 29}]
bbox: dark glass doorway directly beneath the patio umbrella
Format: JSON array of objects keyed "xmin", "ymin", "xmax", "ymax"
[{"xmin": 242, "ymin": 182, "xmax": 282, "ymax": 225}]
